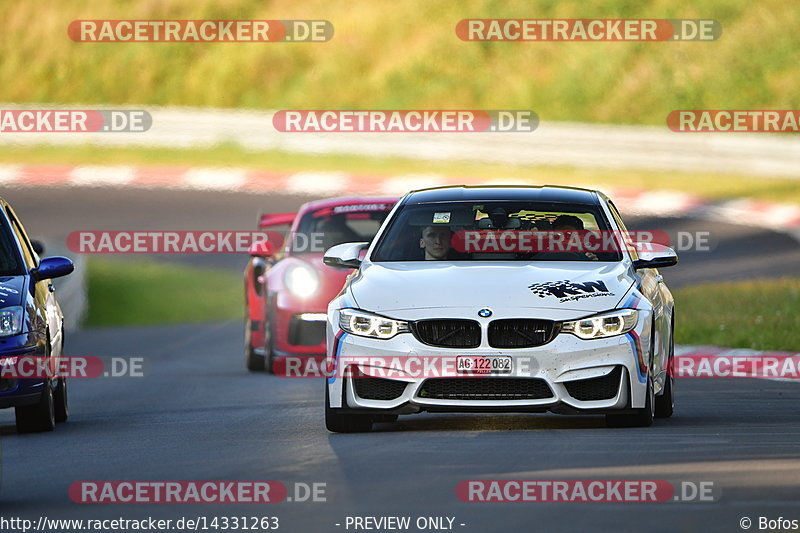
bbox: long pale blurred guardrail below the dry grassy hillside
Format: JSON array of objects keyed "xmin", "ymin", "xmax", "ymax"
[{"xmin": 0, "ymin": 103, "xmax": 800, "ymax": 178}]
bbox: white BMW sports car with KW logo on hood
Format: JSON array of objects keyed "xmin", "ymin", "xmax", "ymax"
[{"xmin": 325, "ymin": 186, "xmax": 677, "ymax": 432}]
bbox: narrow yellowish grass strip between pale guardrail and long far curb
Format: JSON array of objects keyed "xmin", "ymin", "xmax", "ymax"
[{"xmin": 6, "ymin": 145, "xmax": 800, "ymax": 203}]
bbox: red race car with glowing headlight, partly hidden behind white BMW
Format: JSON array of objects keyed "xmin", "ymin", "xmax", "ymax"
[{"xmin": 244, "ymin": 197, "xmax": 397, "ymax": 373}]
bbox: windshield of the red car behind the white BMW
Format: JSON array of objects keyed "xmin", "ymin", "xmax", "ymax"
[{"xmin": 289, "ymin": 203, "xmax": 394, "ymax": 254}]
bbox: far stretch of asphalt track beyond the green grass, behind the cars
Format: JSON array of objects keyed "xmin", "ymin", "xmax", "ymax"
[{"xmin": 2, "ymin": 187, "xmax": 800, "ymax": 282}]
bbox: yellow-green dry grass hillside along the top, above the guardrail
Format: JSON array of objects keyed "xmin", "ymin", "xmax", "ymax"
[{"xmin": 0, "ymin": 0, "xmax": 800, "ymax": 124}]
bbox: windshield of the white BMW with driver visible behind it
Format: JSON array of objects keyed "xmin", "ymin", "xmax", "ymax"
[{"xmin": 371, "ymin": 201, "xmax": 622, "ymax": 262}]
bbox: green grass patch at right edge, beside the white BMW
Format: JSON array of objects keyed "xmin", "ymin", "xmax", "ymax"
[{"xmin": 674, "ymin": 278, "xmax": 800, "ymax": 352}]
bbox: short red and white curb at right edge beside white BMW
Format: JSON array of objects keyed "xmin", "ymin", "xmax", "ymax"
[{"xmin": 673, "ymin": 346, "xmax": 800, "ymax": 382}]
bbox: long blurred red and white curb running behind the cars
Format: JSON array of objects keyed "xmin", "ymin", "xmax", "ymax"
[{"xmin": 0, "ymin": 165, "xmax": 800, "ymax": 238}]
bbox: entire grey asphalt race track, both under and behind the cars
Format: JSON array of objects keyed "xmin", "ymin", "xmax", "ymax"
[{"xmin": 0, "ymin": 185, "xmax": 800, "ymax": 532}]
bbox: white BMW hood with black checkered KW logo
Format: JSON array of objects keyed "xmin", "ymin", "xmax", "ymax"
[{"xmin": 350, "ymin": 261, "xmax": 634, "ymax": 313}]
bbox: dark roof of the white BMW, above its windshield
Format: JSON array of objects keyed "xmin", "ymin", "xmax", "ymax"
[{"xmin": 404, "ymin": 185, "xmax": 599, "ymax": 205}]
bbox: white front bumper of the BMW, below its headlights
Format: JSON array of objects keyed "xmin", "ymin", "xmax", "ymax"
[{"xmin": 328, "ymin": 331, "xmax": 648, "ymax": 414}]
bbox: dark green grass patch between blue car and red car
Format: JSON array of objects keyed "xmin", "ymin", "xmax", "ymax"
[{"xmin": 84, "ymin": 258, "xmax": 243, "ymax": 326}]
